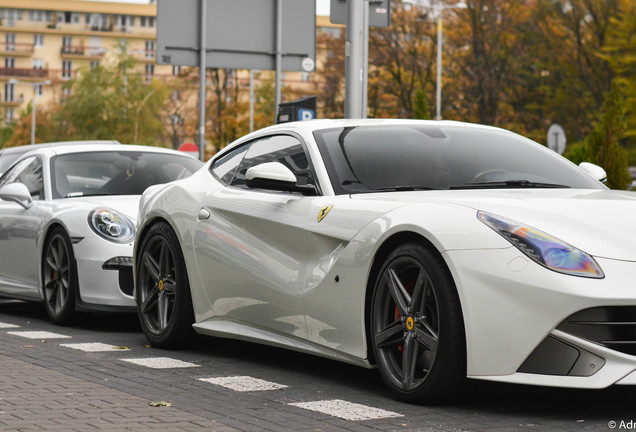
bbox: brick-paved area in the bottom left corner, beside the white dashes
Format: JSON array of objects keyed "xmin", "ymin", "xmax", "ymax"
[{"xmin": 0, "ymin": 355, "xmax": 236, "ymax": 432}]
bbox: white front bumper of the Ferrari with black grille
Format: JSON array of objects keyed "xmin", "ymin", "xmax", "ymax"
[{"xmin": 444, "ymin": 247, "xmax": 636, "ymax": 388}]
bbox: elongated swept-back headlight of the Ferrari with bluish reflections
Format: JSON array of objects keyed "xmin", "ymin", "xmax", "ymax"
[{"xmin": 477, "ymin": 211, "xmax": 605, "ymax": 279}]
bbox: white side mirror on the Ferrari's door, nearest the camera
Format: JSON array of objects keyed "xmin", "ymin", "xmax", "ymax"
[{"xmin": 245, "ymin": 162, "xmax": 316, "ymax": 195}]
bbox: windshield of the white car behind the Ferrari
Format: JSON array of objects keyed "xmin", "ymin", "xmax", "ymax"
[{"xmin": 51, "ymin": 151, "xmax": 202, "ymax": 198}]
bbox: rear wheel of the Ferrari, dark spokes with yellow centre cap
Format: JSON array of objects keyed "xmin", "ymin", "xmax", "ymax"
[{"xmin": 135, "ymin": 222, "xmax": 195, "ymax": 348}]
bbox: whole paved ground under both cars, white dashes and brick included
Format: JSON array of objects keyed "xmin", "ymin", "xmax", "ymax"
[{"xmin": 0, "ymin": 300, "xmax": 636, "ymax": 432}]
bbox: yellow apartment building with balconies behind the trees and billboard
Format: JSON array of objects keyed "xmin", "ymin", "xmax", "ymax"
[{"xmin": 0, "ymin": 0, "xmax": 342, "ymax": 124}]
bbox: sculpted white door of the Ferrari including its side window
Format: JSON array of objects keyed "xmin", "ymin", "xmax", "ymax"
[{"xmin": 194, "ymin": 135, "xmax": 322, "ymax": 338}]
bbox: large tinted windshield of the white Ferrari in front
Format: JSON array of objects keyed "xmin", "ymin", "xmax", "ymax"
[{"xmin": 314, "ymin": 123, "xmax": 604, "ymax": 194}]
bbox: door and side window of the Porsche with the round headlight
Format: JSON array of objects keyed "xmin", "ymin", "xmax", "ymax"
[{"xmin": 0, "ymin": 156, "xmax": 44, "ymax": 297}]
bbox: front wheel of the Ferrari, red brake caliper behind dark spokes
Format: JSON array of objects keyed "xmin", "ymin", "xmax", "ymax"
[{"xmin": 370, "ymin": 243, "xmax": 466, "ymax": 404}]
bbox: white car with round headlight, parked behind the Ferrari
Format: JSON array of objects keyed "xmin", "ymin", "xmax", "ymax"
[{"xmin": 0, "ymin": 143, "xmax": 202, "ymax": 324}]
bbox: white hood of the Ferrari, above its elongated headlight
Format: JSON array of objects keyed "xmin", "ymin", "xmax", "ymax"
[{"xmin": 353, "ymin": 189, "xmax": 636, "ymax": 261}]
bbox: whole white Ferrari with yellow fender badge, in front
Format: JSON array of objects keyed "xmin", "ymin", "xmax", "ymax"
[{"xmin": 133, "ymin": 120, "xmax": 636, "ymax": 402}]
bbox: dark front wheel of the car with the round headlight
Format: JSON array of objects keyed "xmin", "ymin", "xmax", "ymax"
[{"xmin": 42, "ymin": 227, "xmax": 78, "ymax": 325}]
